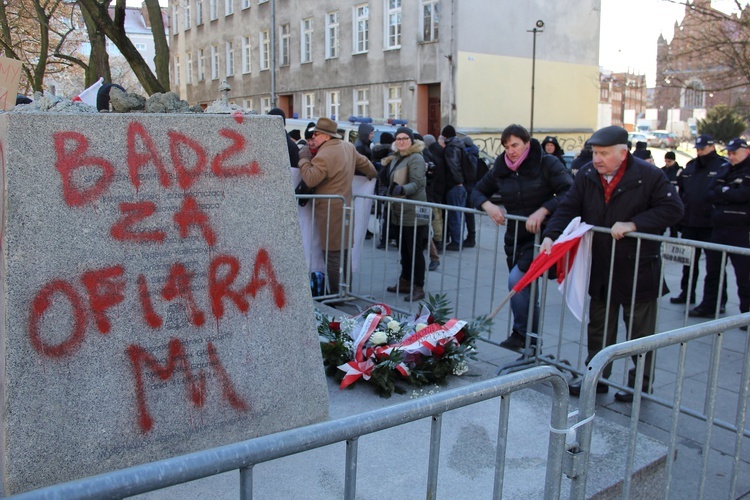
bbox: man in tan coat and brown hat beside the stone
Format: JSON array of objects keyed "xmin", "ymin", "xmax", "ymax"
[{"xmin": 299, "ymin": 118, "xmax": 378, "ymax": 293}]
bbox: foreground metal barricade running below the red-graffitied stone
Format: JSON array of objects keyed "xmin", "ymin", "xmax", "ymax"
[{"xmin": 11, "ymin": 367, "xmax": 568, "ymax": 500}]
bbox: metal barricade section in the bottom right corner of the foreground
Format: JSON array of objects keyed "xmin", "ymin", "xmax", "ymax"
[{"xmin": 565, "ymin": 313, "xmax": 750, "ymax": 499}]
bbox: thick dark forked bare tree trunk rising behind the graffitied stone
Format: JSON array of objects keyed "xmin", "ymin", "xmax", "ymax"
[{"xmin": 78, "ymin": 0, "xmax": 169, "ymax": 95}]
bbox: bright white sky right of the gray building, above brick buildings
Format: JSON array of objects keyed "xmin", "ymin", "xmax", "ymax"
[{"xmin": 599, "ymin": 0, "xmax": 748, "ymax": 87}]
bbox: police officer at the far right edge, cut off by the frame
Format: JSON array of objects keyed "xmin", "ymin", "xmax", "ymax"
[{"xmin": 693, "ymin": 139, "xmax": 750, "ymax": 329}]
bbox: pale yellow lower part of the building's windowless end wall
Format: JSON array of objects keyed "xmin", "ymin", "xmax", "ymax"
[{"xmin": 455, "ymin": 52, "xmax": 599, "ymax": 138}]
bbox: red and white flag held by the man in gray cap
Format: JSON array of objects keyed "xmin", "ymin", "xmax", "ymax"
[{"xmin": 489, "ymin": 217, "xmax": 594, "ymax": 321}]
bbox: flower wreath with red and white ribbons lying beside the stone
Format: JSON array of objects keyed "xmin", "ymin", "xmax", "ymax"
[{"xmin": 316, "ymin": 295, "xmax": 490, "ymax": 397}]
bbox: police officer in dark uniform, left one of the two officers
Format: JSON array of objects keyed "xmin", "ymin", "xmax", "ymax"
[{"xmin": 669, "ymin": 134, "xmax": 727, "ymax": 310}]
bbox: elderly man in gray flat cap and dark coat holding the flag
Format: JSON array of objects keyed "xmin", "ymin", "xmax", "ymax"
[{"xmin": 540, "ymin": 126, "xmax": 683, "ymax": 401}]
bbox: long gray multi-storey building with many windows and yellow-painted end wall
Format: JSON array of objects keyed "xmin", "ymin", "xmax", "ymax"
[{"xmin": 170, "ymin": 0, "xmax": 600, "ymax": 153}]
